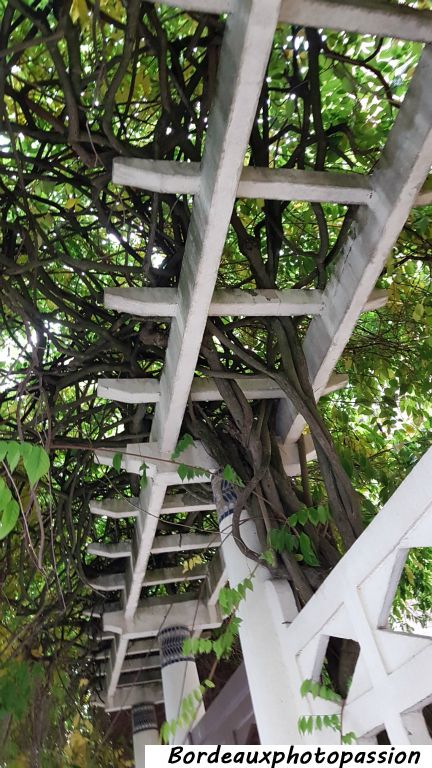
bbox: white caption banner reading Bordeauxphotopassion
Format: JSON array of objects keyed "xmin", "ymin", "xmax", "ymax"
[{"xmin": 145, "ymin": 745, "xmax": 432, "ymax": 768}]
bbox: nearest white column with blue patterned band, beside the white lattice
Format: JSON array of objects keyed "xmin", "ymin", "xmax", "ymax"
[{"xmin": 213, "ymin": 478, "xmax": 299, "ymax": 744}]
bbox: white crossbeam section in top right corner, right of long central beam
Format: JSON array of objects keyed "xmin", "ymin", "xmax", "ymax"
[{"xmin": 279, "ymin": 0, "xmax": 432, "ymax": 42}]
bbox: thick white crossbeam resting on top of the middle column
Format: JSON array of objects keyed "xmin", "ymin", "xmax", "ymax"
[{"xmin": 103, "ymin": 598, "xmax": 222, "ymax": 640}]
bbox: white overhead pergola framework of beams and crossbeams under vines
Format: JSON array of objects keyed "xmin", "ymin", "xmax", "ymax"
[{"xmin": 89, "ymin": 0, "xmax": 432, "ymax": 743}]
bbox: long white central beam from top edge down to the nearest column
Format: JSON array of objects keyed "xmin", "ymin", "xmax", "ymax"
[{"xmin": 151, "ymin": 0, "xmax": 281, "ymax": 451}]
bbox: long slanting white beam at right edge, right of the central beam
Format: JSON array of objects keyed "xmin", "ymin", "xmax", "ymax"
[{"xmin": 279, "ymin": 46, "xmax": 432, "ymax": 442}]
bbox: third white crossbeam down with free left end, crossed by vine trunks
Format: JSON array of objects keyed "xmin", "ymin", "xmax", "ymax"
[{"xmin": 98, "ymin": 373, "xmax": 348, "ymax": 404}]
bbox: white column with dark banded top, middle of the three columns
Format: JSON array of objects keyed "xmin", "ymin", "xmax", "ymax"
[{"xmin": 158, "ymin": 624, "xmax": 205, "ymax": 744}]
